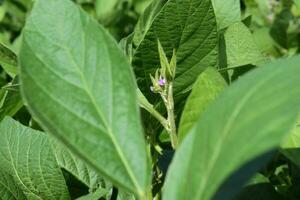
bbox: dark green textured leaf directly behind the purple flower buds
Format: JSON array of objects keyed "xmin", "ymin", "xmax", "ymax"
[{"xmin": 133, "ymin": 0, "xmax": 217, "ymax": 98}]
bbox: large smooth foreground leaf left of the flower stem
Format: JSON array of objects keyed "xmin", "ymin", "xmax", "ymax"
[{"xmin": 20, "ymin": 0, "xmax": 150, "ymax": 196}]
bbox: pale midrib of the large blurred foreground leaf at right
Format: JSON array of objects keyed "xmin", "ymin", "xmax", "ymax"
[{"xmin": 195, "ymin": 69, "xmax": 278, "ymax": 199}]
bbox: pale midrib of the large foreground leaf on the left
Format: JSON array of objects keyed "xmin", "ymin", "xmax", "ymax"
[{"xmin": 22, "ymin": 17, "xmax": 144, "ymax": 196}]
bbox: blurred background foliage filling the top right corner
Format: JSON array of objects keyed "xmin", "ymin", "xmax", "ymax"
[{"xmin": 241, "ymin": 0, "xmax": 300, "ymax": 57}]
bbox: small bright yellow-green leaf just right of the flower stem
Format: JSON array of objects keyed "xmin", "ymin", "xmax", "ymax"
[{"xmin": 178, "ymin": 68, "xmax": 227, "ymax": 143}]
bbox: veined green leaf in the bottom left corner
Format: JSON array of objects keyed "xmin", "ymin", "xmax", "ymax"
[{"xmin": 0, "ymin": 117, "xmax": 69, "ymax": 200}]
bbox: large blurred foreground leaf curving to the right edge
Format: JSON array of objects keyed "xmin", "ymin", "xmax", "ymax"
[{"xmin": 164, "ymin": 57, "xmax": 300, "ymax": 200}]
